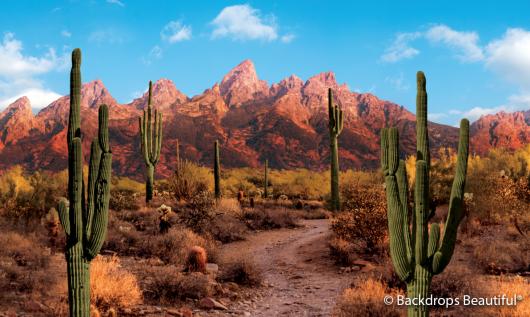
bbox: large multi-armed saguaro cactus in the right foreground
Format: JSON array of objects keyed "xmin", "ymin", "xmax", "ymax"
[{"xmin": 381, "ymin": 72, "xmax": 469, "ymax": 316}]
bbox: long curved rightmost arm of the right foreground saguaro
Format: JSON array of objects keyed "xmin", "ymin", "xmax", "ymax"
[{"xmin": 433, "ymin": 119, "xmax": 469, "ymax": 274}]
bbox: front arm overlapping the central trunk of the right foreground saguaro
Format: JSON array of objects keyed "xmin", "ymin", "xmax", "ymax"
[{"xmin": 414, "ymin": 160, "xmax": 429, "ymax": 265}]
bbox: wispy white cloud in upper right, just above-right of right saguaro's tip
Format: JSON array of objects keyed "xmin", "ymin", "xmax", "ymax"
[{"xmin": 425, "ymin": 25, "xmax": 484, "ymax": 62}]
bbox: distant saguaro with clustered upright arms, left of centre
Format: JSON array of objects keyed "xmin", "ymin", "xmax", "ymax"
[{"xmin": 138, "ymin": 81, "xmax": 162, "ymax": 203}]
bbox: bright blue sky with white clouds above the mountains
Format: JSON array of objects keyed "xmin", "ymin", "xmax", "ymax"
[{"xmin": 0, "ymin": 0, "xmax": 530, "ymax": 125}]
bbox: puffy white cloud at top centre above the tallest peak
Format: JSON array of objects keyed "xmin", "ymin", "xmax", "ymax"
[{"xmin": 211, "ymin": 4, "xmax": 278, "ymax": 41}]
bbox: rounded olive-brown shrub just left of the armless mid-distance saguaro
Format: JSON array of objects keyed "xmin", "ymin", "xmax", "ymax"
[{"xmin": 168, "ymin": 160, "xmax": 213, "ymax": 200}]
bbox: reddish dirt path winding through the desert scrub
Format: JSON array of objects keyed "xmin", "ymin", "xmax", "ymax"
[{"xmin": 216, "ymin": 219, "xmax": 348, "ymax": 317}]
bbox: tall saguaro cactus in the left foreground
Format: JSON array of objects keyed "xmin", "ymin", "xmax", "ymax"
[{"xmin": 58, "ymin": 49, "xmax": 112, "ymax": 317}]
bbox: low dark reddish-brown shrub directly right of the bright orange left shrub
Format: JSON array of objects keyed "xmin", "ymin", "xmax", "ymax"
[{"xmin": 144, "ymin": 266, "xmax": 213, "ymax": 304}]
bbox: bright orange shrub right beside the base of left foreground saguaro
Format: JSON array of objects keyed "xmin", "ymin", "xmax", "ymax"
[{"xmin": 90, "ymin": 256, "xmax": 142, "ymax": 310}]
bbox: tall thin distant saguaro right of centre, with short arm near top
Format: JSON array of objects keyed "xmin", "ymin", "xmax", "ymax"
[{"xmin": 328, "ymin": 88, "xmax": 344, "ymax": 211}]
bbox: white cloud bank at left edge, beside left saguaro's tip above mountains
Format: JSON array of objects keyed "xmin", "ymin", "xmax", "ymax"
[{"xmin": 0, "ymin": 33, "xmax": 68, "ymax": 110}]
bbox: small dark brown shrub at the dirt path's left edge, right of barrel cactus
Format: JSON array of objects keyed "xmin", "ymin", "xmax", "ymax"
[{"xmin": 219, "ymin": 259, "xmax": 263, "ymax": 286}]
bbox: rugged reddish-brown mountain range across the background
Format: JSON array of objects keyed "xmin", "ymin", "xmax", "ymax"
[{"xmin": 0, "ymin": 60, "xmax": 530, "ymax": 178}]
